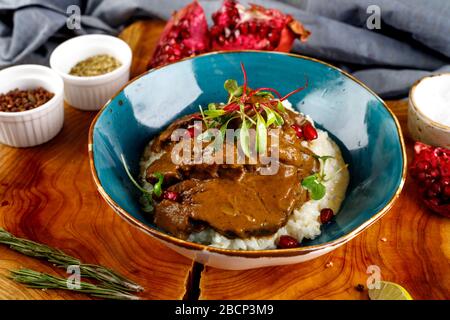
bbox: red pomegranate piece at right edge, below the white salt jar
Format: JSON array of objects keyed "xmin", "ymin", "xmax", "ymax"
[{"xmin": 410, "ymin": 142, "xmax": 450, "ymax": 218}]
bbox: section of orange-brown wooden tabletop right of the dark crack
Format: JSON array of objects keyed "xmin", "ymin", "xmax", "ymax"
[{"xmin": 200, "ymin": 101, "xmax": 450, "ymax": 299}]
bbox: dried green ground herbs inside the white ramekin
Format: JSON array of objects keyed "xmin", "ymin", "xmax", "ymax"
[{"xmin": 69, "ymin": 54, "xmax": 122, "ymax": 77}]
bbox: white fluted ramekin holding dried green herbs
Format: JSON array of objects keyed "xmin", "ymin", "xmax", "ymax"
[{"xmin": 50, "ymin": 34, "xmax": 132, "ymax": 110}]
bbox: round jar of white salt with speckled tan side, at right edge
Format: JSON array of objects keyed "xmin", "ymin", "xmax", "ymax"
[{"xmin": 408, "ymin": 73, "xmax": 450, "ymax": 148}]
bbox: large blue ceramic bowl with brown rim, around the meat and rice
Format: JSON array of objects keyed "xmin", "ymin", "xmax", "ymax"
[{"xmin": 89, "ymin": 51, "xmax": 406, "ymax": 269}]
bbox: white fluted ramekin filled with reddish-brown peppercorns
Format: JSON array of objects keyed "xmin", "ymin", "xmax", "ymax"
[{"xmin": 0, "ymin": 64, "xmax": 64, "ymax": 148}]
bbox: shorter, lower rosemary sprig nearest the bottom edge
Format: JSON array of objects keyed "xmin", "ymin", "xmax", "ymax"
[{"xmin": 10, "ymin": 269, "xmax": 139, "ymax": 300}]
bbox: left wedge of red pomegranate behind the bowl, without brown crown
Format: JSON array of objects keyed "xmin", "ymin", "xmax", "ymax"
[{"xmin": 149, "ymin": 1, "xmax": 210, "ymax": 68}]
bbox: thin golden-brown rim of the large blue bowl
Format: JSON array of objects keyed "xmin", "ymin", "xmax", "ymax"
[{"xmin": 88, "ymin": 50, "xmax": 407, "ymax": 258}]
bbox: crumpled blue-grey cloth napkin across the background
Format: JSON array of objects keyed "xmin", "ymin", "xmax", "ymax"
[{"xmin": 0, "ymin": 0, "xmax": 450, "ymax": 98}]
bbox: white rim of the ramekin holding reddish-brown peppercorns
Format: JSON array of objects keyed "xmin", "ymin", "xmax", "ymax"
[{"xmin": 0, "ymin": 64, "xmax": 64, "ymax": 118}]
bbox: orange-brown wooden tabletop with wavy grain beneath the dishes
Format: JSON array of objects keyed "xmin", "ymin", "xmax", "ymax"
[{"xmin": 0, "ymin": 21, "xmax": 450, "ymax": 299}]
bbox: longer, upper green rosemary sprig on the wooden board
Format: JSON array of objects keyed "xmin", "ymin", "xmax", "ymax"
[{"xmin": 0, "ymin": 228, "xmax": 144, "ymax": 292}]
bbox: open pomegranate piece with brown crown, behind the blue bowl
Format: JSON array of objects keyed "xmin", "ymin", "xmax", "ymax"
[{"xmin": 211, "ymin": 0, "xmax": 310, "ymax": 52}]
